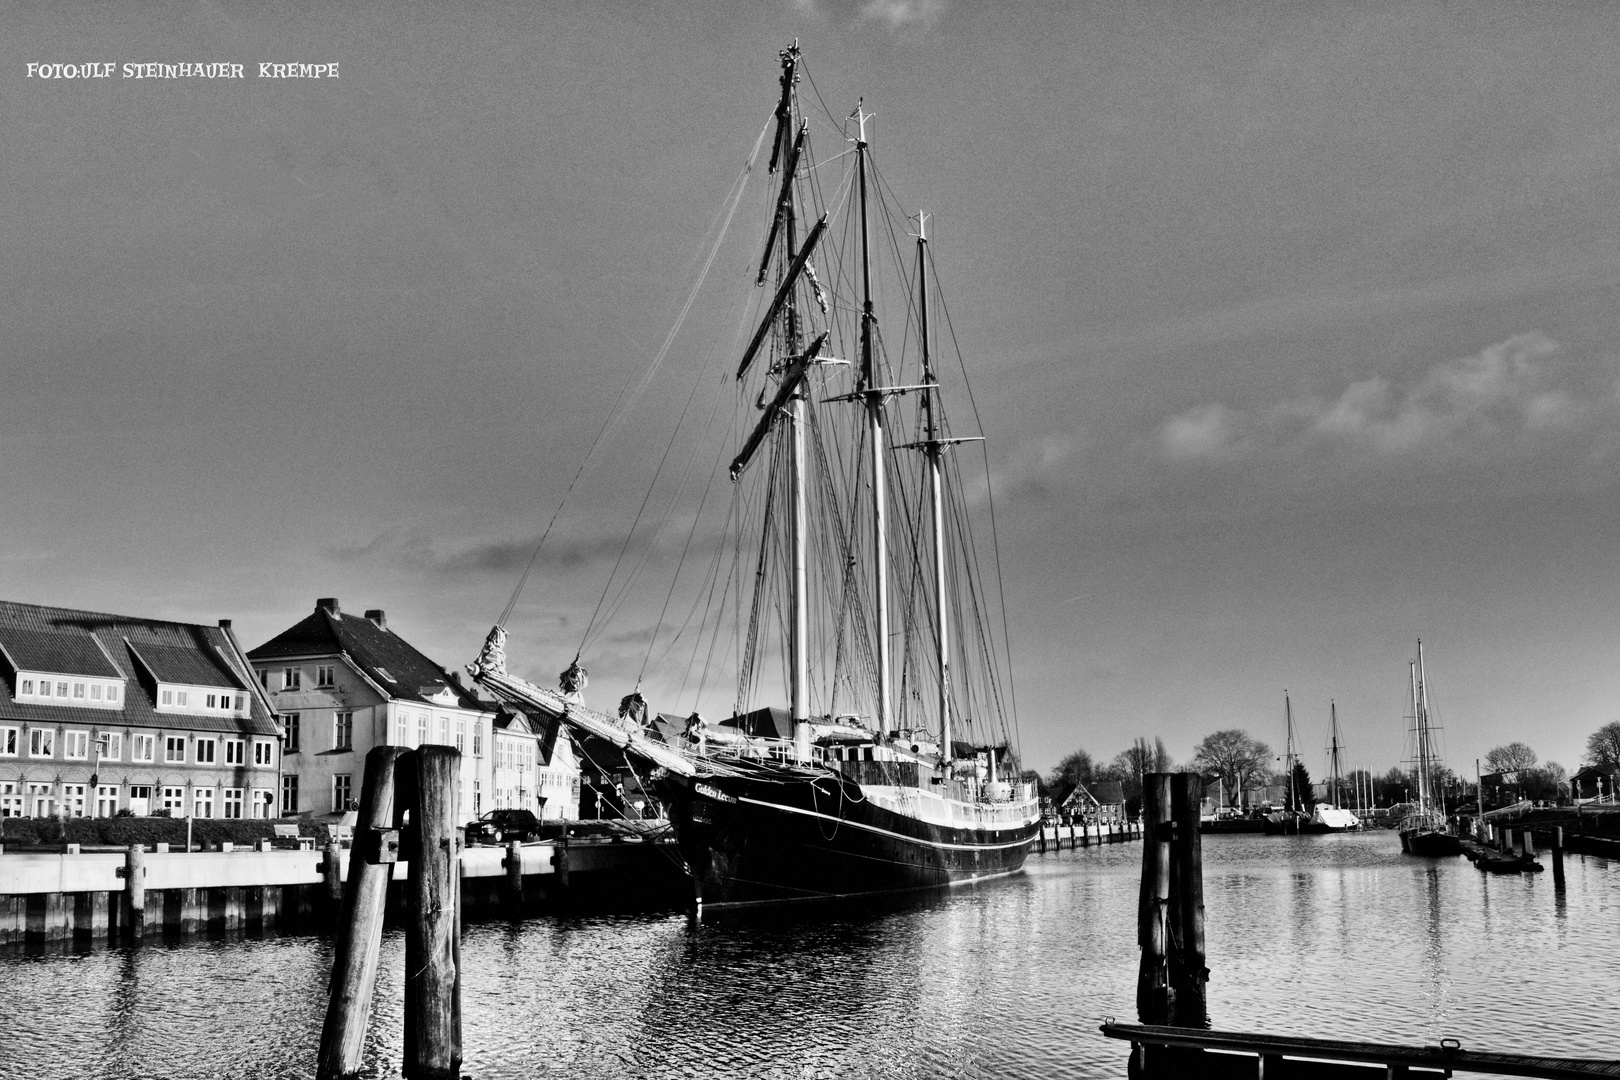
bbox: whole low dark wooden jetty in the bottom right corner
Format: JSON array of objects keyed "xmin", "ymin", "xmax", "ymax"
[{"xmin": 1102, "ymin": 1020, "xmax": 1620, "ymax": 1080}]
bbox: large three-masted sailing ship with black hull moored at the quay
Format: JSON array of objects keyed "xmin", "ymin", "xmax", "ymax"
[{"xmin": 468, "ymin": 42, "xmax": 1040, "ymax": 907}]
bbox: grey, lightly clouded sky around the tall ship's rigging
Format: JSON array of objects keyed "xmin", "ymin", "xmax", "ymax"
[{"xmin": 9, "ymin": 0, "xmax": 1620, "ymax": 774}]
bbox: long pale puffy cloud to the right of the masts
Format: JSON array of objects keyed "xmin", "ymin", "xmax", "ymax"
[{"xmin": 1157, "ymin": 332, "xmax": 1617, "ymax": 461}]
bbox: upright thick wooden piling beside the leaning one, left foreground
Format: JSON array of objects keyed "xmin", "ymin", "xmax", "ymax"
[{"xmin": 402, "ymin": 746, "xmax": 462, "ymax": 1080}]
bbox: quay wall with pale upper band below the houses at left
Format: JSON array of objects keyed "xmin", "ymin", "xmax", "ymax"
[{"xmin": 0, "ymin": 839, "xmax": 692, "ymax": 947}]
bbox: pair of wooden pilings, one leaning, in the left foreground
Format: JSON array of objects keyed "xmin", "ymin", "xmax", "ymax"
[{"xmin": 316, "ymin": 746, "xmax": 462, "ymax": 1080}]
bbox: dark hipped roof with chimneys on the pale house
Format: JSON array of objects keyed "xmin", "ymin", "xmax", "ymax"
[{"xmin": 248, "ymin": 597, "xmax": 484, "ymax": 711}]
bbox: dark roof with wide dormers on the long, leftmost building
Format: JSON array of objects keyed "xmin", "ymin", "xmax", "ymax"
[{"xmin": 0, "ymin": 601, "xmax": 277, "ymax": 735}]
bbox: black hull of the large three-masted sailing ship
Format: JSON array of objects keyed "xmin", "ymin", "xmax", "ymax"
[{"xmin": 663, "ymin": 764, "xmax": 1038, "ymax": 908}]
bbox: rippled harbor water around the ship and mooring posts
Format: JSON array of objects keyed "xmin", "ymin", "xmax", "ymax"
[{"xmin": 0, "ymin": 831, "xmax": 1620, "ymax": 1080}]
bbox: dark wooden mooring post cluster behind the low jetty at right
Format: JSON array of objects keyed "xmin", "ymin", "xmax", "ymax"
[{"xmin": 1136, "ymin": 772, "xmax": 1209, "ymax": 1028}]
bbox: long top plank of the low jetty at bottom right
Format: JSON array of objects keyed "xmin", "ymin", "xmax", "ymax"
[{"xmin": 1102, "ymin": 1023, "xmax": 1620, "ymax": 1080}]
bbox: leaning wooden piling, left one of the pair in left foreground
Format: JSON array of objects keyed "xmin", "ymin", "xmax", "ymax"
[{"xmin": 316, "ymin": 746, "xmax": 408, "ymax": 1080}]
